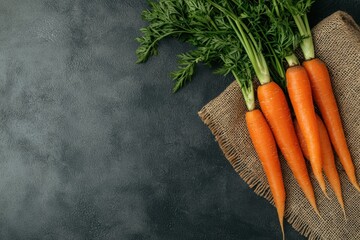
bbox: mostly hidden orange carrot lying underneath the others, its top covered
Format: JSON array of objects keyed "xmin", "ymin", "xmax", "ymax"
[{"xmin": 294, "ymin": 115, "xmax": 346, "ymax": 219}]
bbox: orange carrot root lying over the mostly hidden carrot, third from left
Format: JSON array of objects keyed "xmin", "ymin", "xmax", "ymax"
[{"xmin": 286, "ymin": 65, "xmax": 328, "ymax": 197}]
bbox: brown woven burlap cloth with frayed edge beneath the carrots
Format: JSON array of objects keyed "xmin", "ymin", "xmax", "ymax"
[{"xmin": 199, "ymin": 11, "xmax": 360, "ymax": 240}]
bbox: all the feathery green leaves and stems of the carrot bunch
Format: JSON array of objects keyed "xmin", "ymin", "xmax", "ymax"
[{"xmin": 136, "ymin": 0, "xmax": 314, "ymax": 110}]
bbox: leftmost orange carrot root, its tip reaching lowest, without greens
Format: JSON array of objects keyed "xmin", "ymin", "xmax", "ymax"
[{"xmin": 245, "ymin": 109, "xmax": 286, "ymax": 239}]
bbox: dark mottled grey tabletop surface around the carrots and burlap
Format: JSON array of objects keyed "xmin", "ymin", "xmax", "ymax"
[{"xmin": 0, "ymin": 0, "xmax": 360, "ymax": 240}]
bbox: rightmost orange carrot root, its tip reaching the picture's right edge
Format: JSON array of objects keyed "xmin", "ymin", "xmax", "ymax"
[{"xmin": 303, "ymin": 58, "xmax": 360, "ymax": 191}]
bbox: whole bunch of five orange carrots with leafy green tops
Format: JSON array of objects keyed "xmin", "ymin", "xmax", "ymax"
[{"xmin": 137, "ymin": 0, "xmax": 360, "ymax": 236}]
